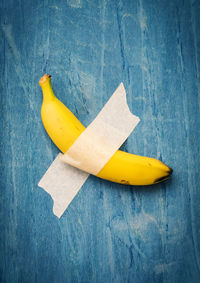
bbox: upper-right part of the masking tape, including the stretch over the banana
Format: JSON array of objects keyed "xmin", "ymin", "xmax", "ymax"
[{"xmin": 62, "ymin": 83, "xmax": 140, "ymax": 175}]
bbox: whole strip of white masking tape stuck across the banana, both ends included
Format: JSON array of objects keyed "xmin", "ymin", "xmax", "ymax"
[{"xmin": 38, "ymin": 83, "xmax": 140, "ymax": 217}]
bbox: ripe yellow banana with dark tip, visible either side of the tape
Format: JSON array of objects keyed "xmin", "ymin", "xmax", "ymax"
[{"xmin": 39, "ymin": 74, "xmax": 172, "ymax": 185}]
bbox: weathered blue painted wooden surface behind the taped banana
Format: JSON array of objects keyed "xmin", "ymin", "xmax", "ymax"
[{"xmin": 0, "ymin": 0, "xmax": 200, "ymax": 283}]
